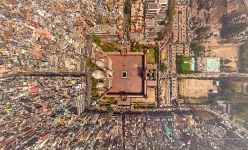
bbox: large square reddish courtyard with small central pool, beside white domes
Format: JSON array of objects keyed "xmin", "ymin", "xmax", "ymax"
[{"xmin": 107, "ymin": 52, "xmax": 146, "ymax": 97}]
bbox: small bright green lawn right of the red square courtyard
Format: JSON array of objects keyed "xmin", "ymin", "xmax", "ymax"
[{"xmin": 177, "ymin": 56, "xmax": 193, "ymax": 74}]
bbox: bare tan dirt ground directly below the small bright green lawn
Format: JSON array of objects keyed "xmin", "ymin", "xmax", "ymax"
[{"xmin": 179, "ymin": 79, "xmax": 218, "ymax": 98}]
